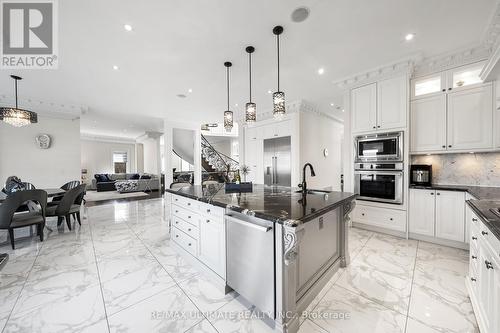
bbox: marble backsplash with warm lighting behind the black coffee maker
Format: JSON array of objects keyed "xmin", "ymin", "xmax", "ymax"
[{"xmin": 411, "ymin": 153, "xmax": 500, "ymax": 186}]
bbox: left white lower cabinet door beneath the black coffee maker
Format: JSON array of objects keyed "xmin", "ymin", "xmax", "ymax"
[{"xmin": 409, "ymin": 189, "xmax": 436, "ymax": 237}]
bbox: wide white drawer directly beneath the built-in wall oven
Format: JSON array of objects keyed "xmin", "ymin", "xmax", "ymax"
[{"xmin": 353, "ymin": 204, "xmax": 406, "ymax": 231}]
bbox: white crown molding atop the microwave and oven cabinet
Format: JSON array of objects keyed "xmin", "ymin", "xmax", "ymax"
[{"xmin": 333, "ymin": 54, "xmax": 414, "ymax": 90}]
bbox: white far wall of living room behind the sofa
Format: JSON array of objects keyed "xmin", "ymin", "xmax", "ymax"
[{"xmin": 81, "ymin": 138, "xmax": 137, "ymax": 181}]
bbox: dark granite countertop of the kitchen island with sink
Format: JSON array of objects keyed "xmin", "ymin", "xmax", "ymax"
[{"xmin": 166, "ymin": 184, "xmax": 356, "ymax": 226}]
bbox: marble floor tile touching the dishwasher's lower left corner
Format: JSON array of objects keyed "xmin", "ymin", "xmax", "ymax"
[{"xmin": 179, "ymin": 274, "xmax": 237, "ymax": 312}]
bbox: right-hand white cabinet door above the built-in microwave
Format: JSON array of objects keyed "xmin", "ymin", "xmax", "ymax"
[{"xmin": 377, "ymin": 76, "xmax": 407, "ymax": 129}]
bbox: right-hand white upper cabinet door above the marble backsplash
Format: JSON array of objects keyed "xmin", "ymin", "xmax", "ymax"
[{"xmin": 447, "ymin": 85, "xmax": 493, "ymax": 149}]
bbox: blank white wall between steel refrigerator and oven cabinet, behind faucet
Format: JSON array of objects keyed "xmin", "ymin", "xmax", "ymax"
[{"xmin": 298, "ymin": 113, "xmax": 344, "ymax": 191}]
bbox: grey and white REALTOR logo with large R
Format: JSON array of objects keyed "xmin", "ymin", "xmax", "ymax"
[{"xmin": 0, "ymin": 0, "xmax": 58, "ymax": 69}]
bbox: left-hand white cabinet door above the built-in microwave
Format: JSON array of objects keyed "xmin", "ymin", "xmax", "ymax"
[{"xmin": 351, "ymin": 83, "xmax": 377, "ymax": 132}]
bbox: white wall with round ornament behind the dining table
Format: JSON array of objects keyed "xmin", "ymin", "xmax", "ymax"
[{"xmin": 0, "ymin": 115, "xmax": 81, "ymax": 188}]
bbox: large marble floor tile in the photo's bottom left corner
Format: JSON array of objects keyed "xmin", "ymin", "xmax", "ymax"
[{"xmin": 3, "ymin": 286, "xmax": 105, "ymax": 333}]
